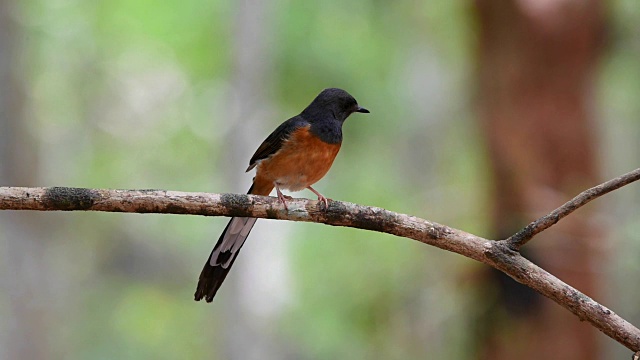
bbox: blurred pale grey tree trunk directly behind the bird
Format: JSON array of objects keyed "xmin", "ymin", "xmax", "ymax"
[{"xmin": 214, "ymin": 0, "xmax": 290, "ymax": 360}]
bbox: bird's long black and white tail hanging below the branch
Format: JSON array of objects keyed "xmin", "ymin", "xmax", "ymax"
[{"xmin": 194, "ymin": 183, "xmax": 271, "ymax": 302}]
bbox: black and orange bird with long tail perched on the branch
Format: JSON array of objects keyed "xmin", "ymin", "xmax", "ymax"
[{"xmin": 194, "ymin": 88, "xmax": 369, "ymax": 302}]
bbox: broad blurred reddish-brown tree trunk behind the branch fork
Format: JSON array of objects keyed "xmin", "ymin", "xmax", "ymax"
[{"xmin": 475, "ymin": 0, "xmax": 606, "ymax": 360}]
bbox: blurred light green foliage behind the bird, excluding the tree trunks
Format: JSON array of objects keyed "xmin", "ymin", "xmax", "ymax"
[{"xmin": 0, "ymin": 0, "xmax": 640, "ymax": 359}]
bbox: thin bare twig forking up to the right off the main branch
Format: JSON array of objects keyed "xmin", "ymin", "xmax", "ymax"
[{"xmin": 507, "ymin": 168, "xmax": 640, "ymax": 251}]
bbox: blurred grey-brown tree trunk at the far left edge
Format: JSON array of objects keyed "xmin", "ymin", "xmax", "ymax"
[{"xmin": 0, "ymin": 0, "xmax": 55, "ymax": 359}]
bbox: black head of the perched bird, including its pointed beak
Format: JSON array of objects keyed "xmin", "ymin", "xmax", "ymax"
[{"xmin": 301, "ymin": 88, "xmax": 369, "ymax": 122}]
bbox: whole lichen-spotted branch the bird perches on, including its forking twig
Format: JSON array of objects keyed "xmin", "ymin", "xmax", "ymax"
[{"xmin": 0, "ymin": 183, "xmax": 640, "ymax": 352}]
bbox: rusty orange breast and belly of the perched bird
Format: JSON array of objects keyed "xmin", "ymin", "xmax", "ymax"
[{"xmin": 255, "ymin": 127, "xmax": 340, "ymax": 191}]
